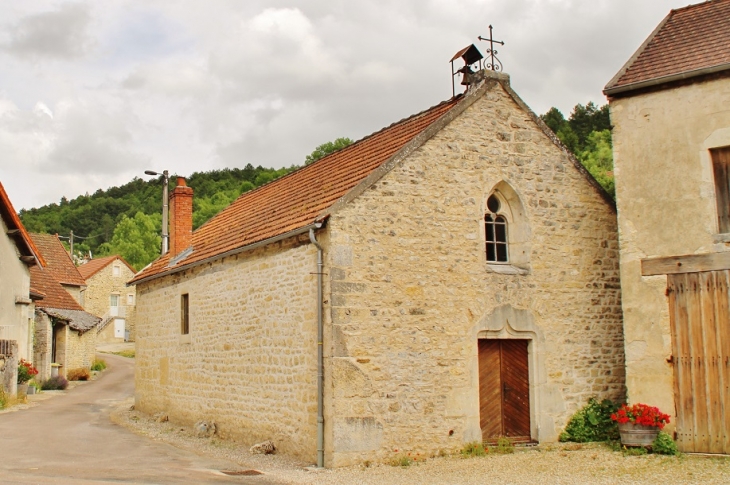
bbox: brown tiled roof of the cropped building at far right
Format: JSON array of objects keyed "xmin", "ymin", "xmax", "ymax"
[{"xmin": 604, "ymin": 0, "xmax": 730, "ymax": 94}]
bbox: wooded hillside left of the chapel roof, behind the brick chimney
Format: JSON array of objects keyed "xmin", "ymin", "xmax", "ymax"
[{"xmin": 20, "ymin": 164, "xmax": 297, "ymax": 269}]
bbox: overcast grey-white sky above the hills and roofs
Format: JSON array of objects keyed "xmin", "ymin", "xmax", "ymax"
[{"xmin": 0, "ymin": 0, "xmax": 686, "ymax": 210}]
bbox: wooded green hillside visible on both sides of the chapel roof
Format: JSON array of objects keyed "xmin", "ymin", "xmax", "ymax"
[{"xmin": 15, "ymin": 103, "xmax": 614, "ymax": 270}]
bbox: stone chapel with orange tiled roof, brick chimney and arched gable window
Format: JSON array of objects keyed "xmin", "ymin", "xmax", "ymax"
[{"xmin": 131, "ymin": 67, "xmax": 624, "ymax": 467}]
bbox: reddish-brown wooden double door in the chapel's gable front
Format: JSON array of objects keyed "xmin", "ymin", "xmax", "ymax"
[{"xmin": 479, "ymin": 339, "xmax": 530, "ymax": 441}]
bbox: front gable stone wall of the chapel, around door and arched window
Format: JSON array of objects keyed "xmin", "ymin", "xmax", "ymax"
[{"xmin": 325, "ymin": 77, "xmax": 624, "ymax": 466}]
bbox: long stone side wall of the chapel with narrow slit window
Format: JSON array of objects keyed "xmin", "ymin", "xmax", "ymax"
[{"xmin": 135, "ymin": 235, "xmax": 317, "ymax": 460}]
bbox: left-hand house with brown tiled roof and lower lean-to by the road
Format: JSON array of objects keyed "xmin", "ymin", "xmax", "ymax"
[{"xmin": 30, "ymin": 234, "xmax": 101, "ymax": 380}]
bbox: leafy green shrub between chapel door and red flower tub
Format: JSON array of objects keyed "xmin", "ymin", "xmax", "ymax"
[{"xmin": 560, "ymin": 398, "xmax": 619, "ymax": 443}]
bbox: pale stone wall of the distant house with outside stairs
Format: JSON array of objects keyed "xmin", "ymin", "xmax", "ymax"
[{"xmin": 84, "ymin": 261, "xmax": 137, "ymax": 344}]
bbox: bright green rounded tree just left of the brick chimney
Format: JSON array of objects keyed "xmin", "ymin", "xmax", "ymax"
[{"xmin": 99, "ymin": 212, "xmax": 162, "ymax": 271}]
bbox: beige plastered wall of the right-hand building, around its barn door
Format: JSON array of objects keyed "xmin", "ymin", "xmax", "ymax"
[{"xmin": 611, "ymin": 78, "xmax": 730, "ymax": 420}]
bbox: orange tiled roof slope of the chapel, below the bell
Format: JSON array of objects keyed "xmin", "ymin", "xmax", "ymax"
[{"xmin": 130, "ymin": 96, "xmax": 462, "ymax": 283}]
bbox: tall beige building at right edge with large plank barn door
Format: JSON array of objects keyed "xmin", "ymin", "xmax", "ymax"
[{"xmin": 604, "ymin": 0, "xmax": 730, "ymax": 453}]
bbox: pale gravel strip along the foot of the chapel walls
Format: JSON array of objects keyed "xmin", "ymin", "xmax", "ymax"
[{"xmin": 112, "ymin": 400, "xmax": 730, "ymax": 485}]
